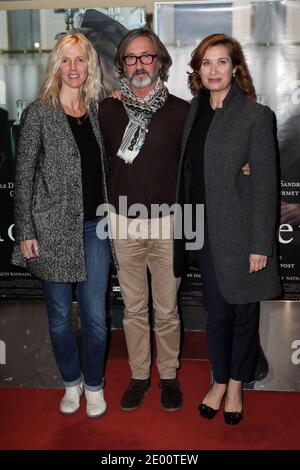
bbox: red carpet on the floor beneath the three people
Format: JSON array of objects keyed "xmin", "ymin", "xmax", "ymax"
[{"xmin": 0, "ymin": 359, "xmax": 300, "ymax": 450}]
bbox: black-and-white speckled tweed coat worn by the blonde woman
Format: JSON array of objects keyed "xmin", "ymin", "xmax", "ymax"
[{"xmin": 12, "ymin": 100, "xmax": 116, "ymax": 282}]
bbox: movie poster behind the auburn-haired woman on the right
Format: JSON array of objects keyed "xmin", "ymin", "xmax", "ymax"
[{"xmin": 155, "ymin": 0, "xmax": 300, "ymax": 304}]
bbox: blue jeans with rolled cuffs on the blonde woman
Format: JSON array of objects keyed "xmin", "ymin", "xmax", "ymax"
[{"xmin": 43, "ymin": 219, "xmax": 109, "ymax": 391}]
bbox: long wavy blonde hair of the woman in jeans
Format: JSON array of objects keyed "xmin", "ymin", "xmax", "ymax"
[{"xmin": 39, "ymin": 32, "xmax": 103, "ymax": 109}]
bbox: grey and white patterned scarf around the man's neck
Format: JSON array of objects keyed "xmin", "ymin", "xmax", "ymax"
[{"xmin": 117, "ymin": 77, "xmax": 168, "ymax": 163}]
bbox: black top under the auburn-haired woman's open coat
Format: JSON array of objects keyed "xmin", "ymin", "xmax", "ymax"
[{"xmin": 186, "ymin": 100, "xmax": 215, "ymax": 204}]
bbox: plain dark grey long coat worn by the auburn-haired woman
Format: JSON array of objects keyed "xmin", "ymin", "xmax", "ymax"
[{"xmin": 174, "ymin": 85, "xmax": 281, "ymax": 304}]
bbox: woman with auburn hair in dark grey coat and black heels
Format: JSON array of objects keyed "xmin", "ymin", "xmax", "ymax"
[{"xmin": 174, "ymin": 34, "xmax": 280, "ymax": 424}]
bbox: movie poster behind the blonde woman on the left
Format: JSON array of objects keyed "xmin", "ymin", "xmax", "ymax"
[{"xmin": 0, "ymin": 7, "xmax": 146, "ymax": 305}]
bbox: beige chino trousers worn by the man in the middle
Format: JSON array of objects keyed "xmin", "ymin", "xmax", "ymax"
[{"xmin": 111, "ymin": 213, "xmax": 180, "ymax": 380}]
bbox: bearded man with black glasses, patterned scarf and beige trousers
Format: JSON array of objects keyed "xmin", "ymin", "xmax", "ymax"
[{"xmin": 99, "ymin": 29, "xmax": 189, "ymax": 411}]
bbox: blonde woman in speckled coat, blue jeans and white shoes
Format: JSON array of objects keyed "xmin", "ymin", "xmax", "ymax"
[{"xmin": 13, "ymin": 33, "xmax": 109, "ymax": 417}]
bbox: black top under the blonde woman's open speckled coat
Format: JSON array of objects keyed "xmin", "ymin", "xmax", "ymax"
[{"xmin": 67, "ymin": 115, "xmax": 104, "ymax": 221}]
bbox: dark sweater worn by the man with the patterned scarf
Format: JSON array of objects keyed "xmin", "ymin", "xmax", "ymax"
[{"xmin": 99, "ymin": 94, "xmax": 189, "ymax": 218}]
